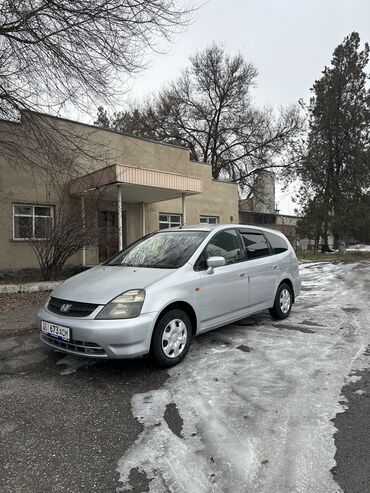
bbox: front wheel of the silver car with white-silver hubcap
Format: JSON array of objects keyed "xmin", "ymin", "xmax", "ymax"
[{"xmin": 151, "ymin": 309, "xmax": 193, "ymax": 368}]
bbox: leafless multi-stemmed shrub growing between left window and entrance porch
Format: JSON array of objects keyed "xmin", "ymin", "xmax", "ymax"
[{"xmin": 11, "ymin": 131, "xmax": 115, "ymax": 280}]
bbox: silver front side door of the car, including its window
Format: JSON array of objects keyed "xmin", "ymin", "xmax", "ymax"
[{"xmin": 195, "ymin": 228, "xmax": 249, "ymax": 329}]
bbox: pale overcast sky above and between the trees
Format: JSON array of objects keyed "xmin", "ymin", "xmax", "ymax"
[{"xmin": 89, "ymin": 0, "xmax": 370, "ymax": 213}]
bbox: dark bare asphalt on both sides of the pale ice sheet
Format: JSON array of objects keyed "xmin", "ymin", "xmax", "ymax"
[{"xmin": 0, "ymin": 262, "xmax": 370, "ymax": 493}]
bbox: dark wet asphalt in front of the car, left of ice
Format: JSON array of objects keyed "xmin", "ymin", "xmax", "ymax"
[{"xmin": 0, "ymin": 333, "xmax": 168, "ymax": 493}]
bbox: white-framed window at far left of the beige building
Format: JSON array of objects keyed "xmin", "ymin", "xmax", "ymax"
[{"xmin": 13, "ymin": 204, "xmax": 54, "ymax": 240}]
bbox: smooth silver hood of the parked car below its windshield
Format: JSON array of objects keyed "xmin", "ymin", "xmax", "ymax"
[{"xmin": 52, "ymin": 265, "xmax": 173, "ymax": 305}]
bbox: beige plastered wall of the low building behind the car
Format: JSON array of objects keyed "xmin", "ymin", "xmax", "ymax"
[{"xmin": 0, "ymin": 115, "xmax": 238, "ymax": 269}]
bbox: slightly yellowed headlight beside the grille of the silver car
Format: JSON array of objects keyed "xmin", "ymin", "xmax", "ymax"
[{"xmin": 95, "ymin": 289, "xmax": 145, "ymax": 320}]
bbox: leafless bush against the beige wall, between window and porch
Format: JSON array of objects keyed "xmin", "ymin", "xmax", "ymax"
[{"xmin": 21, "ymin": 141, "xmax": 100, "ymax": 280}]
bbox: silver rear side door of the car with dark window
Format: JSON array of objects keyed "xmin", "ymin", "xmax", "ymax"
[{"xmin": 239, "ymin": 228, "xmax": 281, "ymax": 309}]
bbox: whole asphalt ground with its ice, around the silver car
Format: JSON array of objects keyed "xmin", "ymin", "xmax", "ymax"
[{"xmin": 0, "ymin": 263, "xmax": 370, "ymax": 493}]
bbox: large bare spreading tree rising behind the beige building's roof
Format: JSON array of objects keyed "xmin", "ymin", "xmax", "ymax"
[{"xmin": 96, "ymin": 44, "xmax": 302, "ymax": 189}]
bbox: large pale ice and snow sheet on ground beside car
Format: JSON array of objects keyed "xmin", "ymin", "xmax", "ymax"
[{"xmin": 117, "ymin": 263, "xmax": 370, "ymax": 493}]
